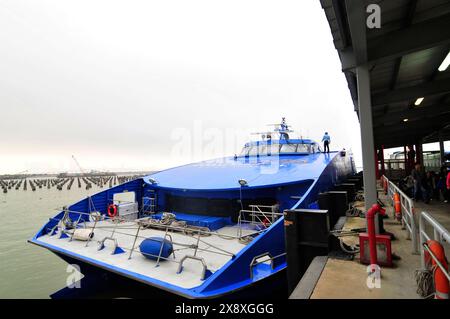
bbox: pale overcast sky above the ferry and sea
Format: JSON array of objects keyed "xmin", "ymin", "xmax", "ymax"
[{"xmin": 0, "ymin": 0, "xmax": 368, "ymax": 173}]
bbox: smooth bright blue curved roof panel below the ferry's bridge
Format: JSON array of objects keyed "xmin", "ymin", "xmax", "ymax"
[{"xmin": 144, "ymin": 152, "xmax": 338, "ymax": 191}]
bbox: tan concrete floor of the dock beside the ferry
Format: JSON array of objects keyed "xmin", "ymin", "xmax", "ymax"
[{"xmin": 290, "ymin": 181, "xmax": 450, "ymax": 299}]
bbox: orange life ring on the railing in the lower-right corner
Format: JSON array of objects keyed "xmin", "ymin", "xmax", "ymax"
[{"xmin": 424, "ymin": 240, "xmax": 450, "ymax": 299}]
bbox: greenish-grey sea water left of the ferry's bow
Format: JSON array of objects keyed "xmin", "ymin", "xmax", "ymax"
[{"xmin": 0, "ymin": 181, "xmax": 106, "ymax": 298}]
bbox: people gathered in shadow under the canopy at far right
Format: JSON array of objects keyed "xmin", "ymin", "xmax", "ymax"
[{"xmin": 403, "ymin": 164, "xmax": 450, "ymax": 204}]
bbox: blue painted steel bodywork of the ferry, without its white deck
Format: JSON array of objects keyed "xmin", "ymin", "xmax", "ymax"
[{"xmin": 30, "ymin": 140, "xmax": 354, "ymax": 298}]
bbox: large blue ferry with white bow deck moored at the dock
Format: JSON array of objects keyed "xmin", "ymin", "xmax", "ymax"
[{"xmin": 29, "ymin": 118, "xmax": 355, "ymax": 298}]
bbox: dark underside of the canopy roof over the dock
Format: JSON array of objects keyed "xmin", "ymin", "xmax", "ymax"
[{"xmin": 321, "ymin": 0, "xmax": 450, "ymax": 147}]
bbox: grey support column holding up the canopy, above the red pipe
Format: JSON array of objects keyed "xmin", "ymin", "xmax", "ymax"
[{"xmin": 356, "ymin": 65, "xmax": 379, "ymax": 234}]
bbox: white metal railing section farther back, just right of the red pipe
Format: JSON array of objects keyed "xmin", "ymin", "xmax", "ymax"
[{"xmin": 381, "ymin": 176, "xmax": 419, "ymax": 254}]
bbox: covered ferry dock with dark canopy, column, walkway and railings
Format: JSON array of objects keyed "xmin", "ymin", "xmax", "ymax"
[{"xmin": 286, "ymin": 0, "xmax": 450, "ymax": 299}]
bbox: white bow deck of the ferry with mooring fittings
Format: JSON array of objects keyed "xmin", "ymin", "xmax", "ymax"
[{"xmin": 37, "ymin": 220, "xmax": 255, "ymax": 289}]
